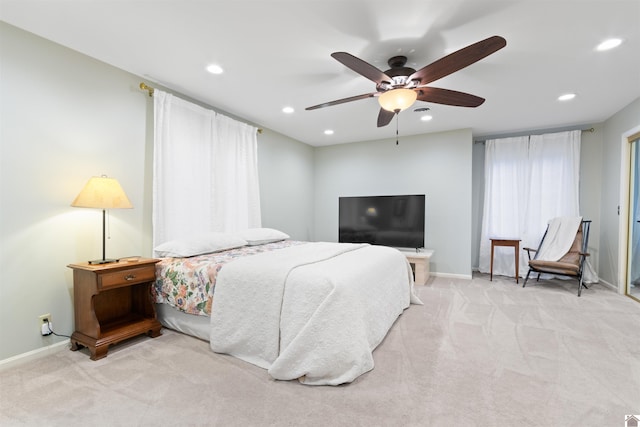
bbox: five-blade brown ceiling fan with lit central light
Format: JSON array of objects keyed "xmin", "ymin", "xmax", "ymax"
[{"xmin": 306, "ymin": 36, "xmax": 507, "ymax": 127}]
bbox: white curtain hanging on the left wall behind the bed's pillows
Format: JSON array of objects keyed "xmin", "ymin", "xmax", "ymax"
[{"xmin": 152, "ymin": 89, "xmax": 261, "ymax": 251}]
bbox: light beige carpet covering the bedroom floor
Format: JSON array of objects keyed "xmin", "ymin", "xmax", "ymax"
[{"xmin": 0, "ymin": 275, "xmax": 640, "ymax": 426}]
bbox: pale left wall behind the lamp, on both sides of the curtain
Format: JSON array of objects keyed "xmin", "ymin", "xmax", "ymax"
[{"xmin": 0, "ymin": 22, "xmax": 314, "ymax": 360}]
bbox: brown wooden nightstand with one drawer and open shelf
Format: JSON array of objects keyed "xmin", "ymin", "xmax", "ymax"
[{"xmin": 68, "ymin": 258, "xmax": 162, "ymax": 360}]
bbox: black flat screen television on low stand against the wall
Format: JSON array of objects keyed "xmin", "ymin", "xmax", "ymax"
[{"xmin": 338, "ymin": 194, "xmax": 425, "ymax": 248}]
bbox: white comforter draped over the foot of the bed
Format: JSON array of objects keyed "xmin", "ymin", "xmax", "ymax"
[{"xmin": 210, "ymin": 242, "xmax": 421, "ymax": 385}]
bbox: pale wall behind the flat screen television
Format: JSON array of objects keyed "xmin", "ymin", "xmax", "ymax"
[{"xmin": 315, "ymin": 130, "xmax": 472, "ymax": 277}]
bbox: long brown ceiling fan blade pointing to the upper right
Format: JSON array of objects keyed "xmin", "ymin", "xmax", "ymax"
[{"xmin": 409, "ymin": 36, "xmax": 507, "ymax": 85}]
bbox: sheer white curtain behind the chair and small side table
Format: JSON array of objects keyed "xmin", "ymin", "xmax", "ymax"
[{"xmin": 479, "ymin": 130, "xmax": 581, "ymax": 276}]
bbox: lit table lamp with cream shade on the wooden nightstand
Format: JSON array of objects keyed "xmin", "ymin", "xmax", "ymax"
[{"xmin": 71, "ymin": 175, "xmax": 133, "ymax": 264}]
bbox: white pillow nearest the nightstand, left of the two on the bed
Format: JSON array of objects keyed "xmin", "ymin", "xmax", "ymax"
[{"xmin": 154, "ymin": 232, "xmax": 247, "ymax": 258}]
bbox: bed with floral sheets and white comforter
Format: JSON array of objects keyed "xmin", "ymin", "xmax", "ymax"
[{"xmin": 152, "ymin": 229, "xmax": 421, "ymax": 385}]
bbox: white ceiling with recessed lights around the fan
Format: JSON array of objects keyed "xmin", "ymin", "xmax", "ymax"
[{"xmin": 0, "ymin": 0, "xmax": 640, "ymax": 146}]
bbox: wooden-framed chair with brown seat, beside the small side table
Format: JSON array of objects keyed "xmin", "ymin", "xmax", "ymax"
[{"xmin": 522, "ymin": 220, "xmax": 591, "ymax": 296}]
